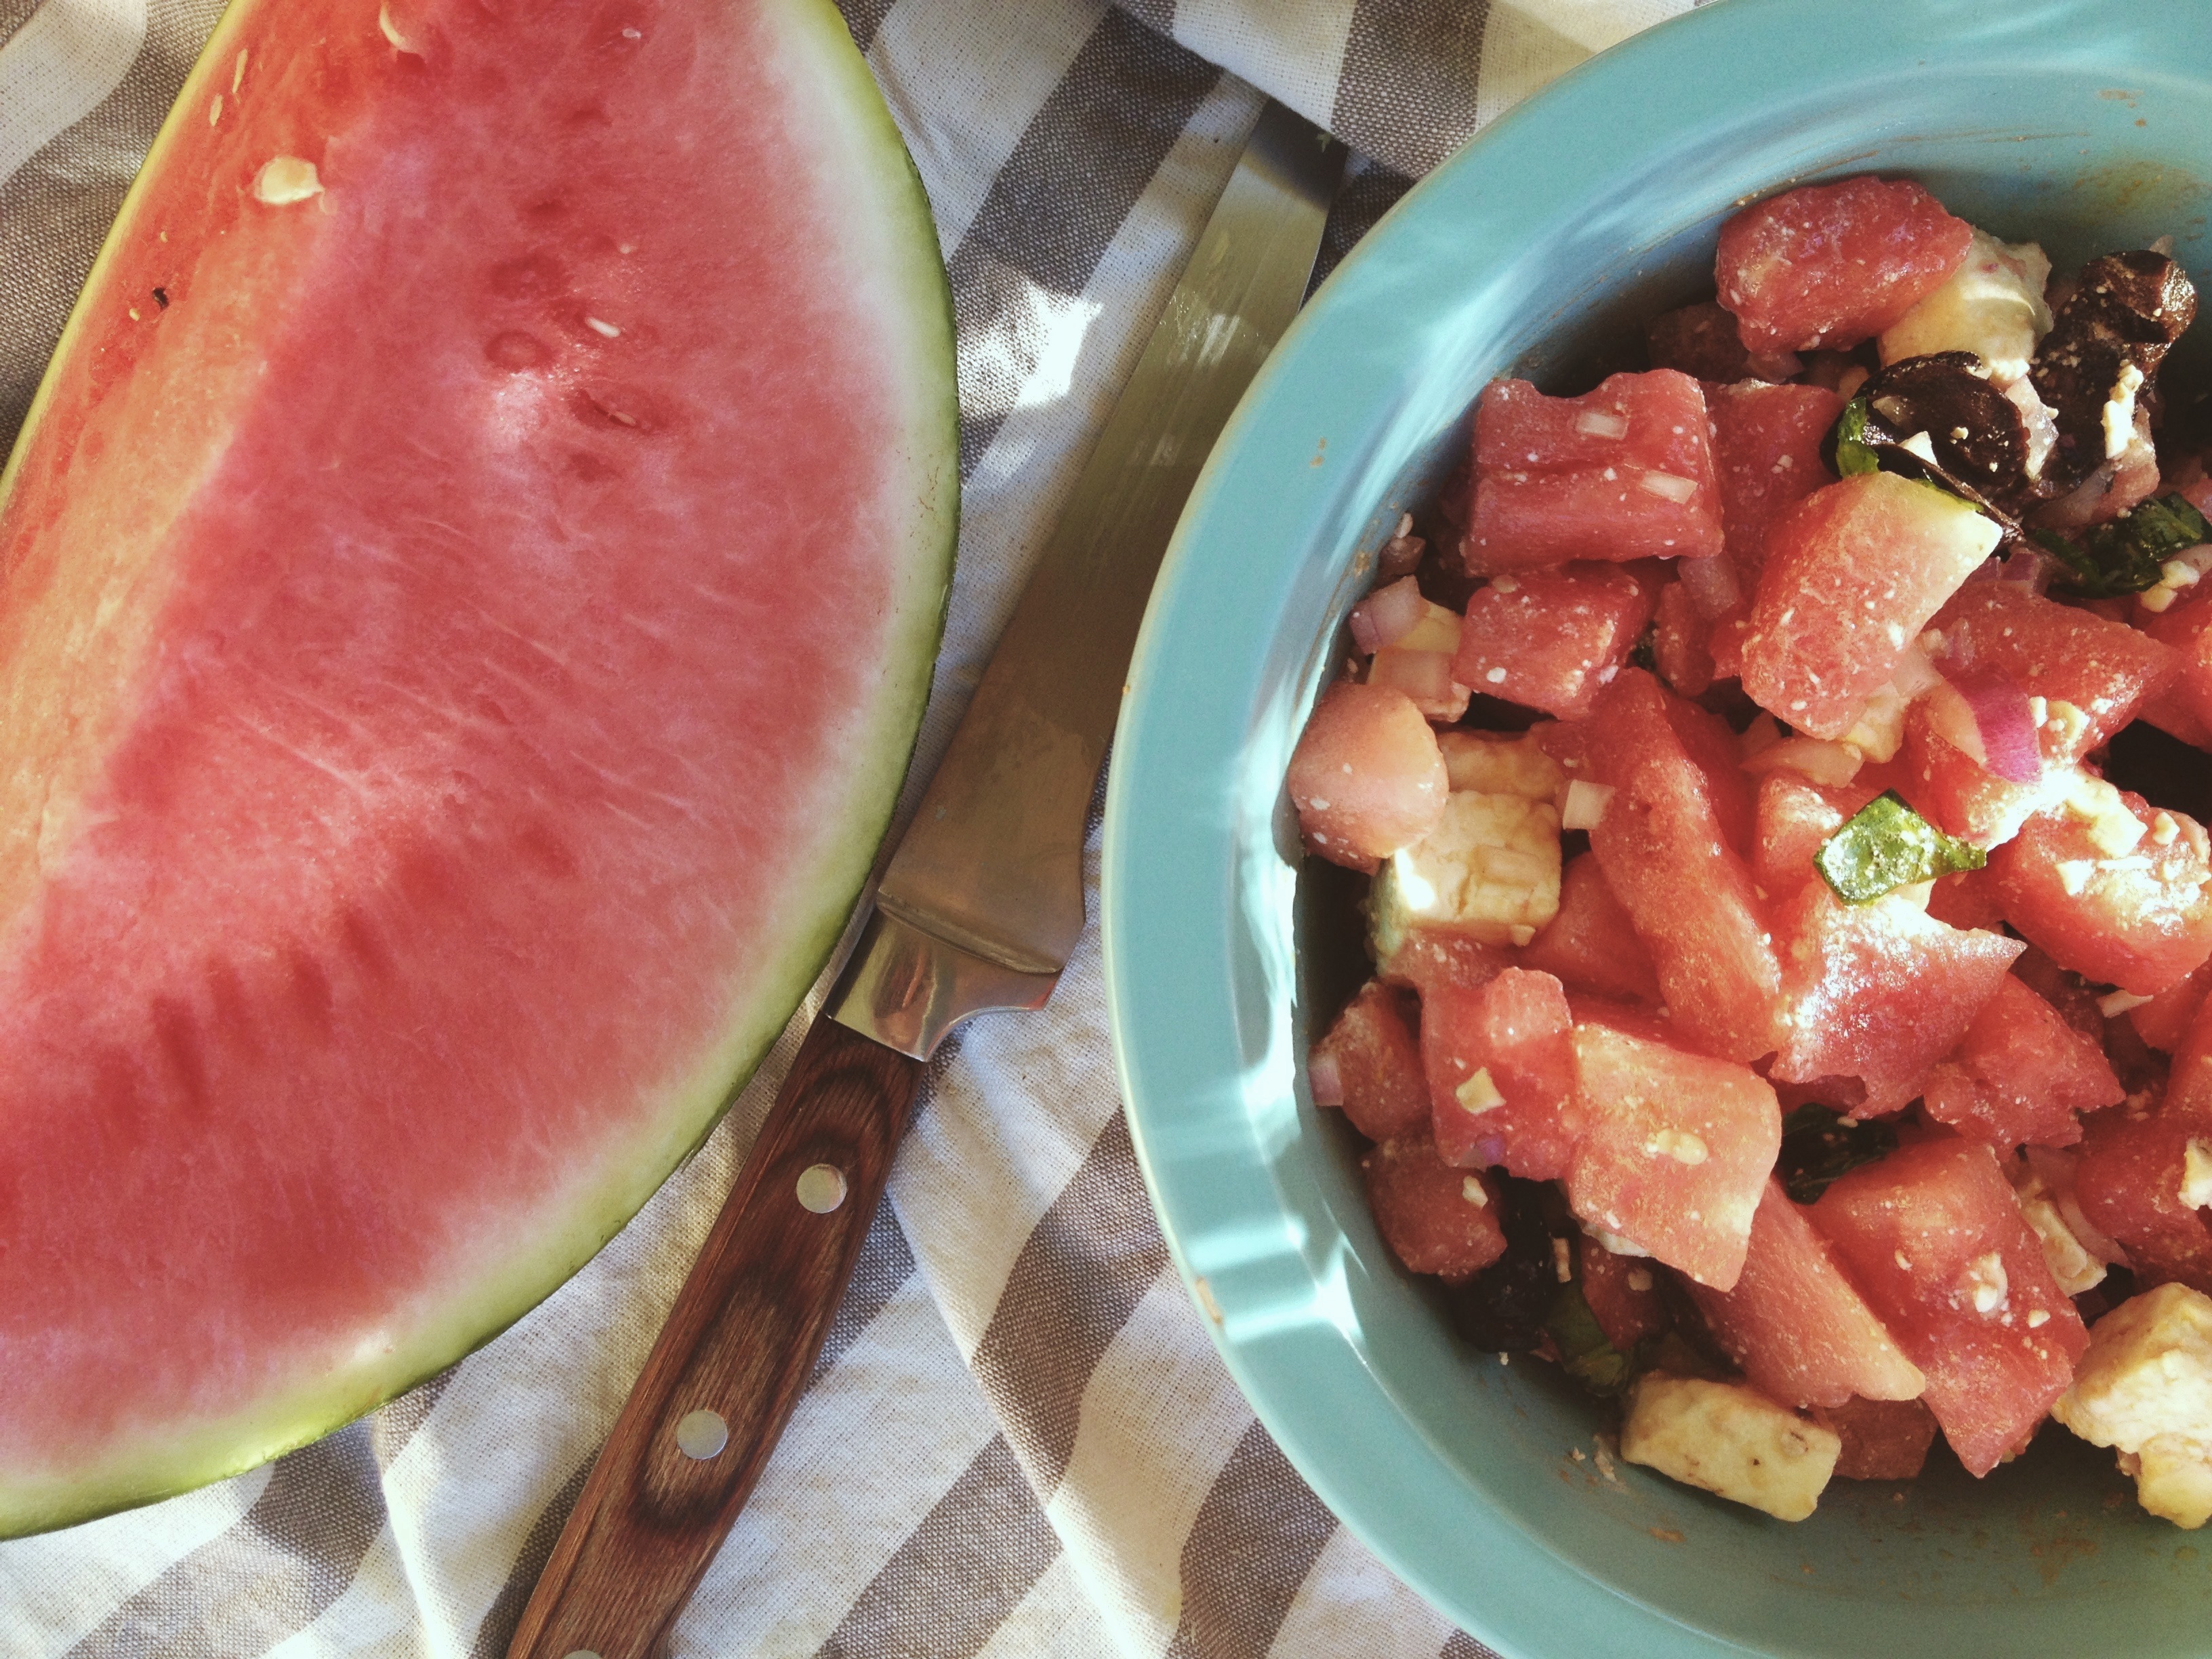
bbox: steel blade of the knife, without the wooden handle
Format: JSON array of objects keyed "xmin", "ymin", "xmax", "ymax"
[{"xmin": 876, "ymin": 104, "xmax": 1345, "ymax": 986}]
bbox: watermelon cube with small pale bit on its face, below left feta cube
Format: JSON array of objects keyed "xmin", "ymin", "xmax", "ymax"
[{"xmin": 1420, "ymin": 966, "xmax": 1582, "ymax": 1181}]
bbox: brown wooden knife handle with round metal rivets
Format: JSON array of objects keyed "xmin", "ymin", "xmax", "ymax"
[{"xmin": 506, "ymin": 1017, "xmax": 922, "ymax": 1659}]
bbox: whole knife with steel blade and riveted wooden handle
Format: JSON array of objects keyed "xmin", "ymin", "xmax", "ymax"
[{"xmin": 506, "ymin": 102, "xmax": 1345, "ymax": 1659}]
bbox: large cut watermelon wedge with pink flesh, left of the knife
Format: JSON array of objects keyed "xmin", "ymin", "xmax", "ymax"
[{"xmin": 0, "ymin": 0, "xmax": 958, "ymax": 1535}]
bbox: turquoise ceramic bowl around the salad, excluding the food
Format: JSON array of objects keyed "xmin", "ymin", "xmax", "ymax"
[{"xmin": 1104, "ymin": 0, "xmax": 2212, "ymax": 1659}]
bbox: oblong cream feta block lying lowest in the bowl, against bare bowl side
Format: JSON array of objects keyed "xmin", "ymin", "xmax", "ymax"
[{"xmin": 1622, "ymin": 1372, "xmax": 1843, "ymax": 1519}]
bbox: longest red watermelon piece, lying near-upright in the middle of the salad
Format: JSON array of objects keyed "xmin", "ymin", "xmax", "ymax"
[{"xmin": 1547, "ymin": 668, "xmax": 1781, "ymax": 1059}]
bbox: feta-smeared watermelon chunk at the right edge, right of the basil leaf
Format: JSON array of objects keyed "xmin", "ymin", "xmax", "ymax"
[{"xmin": 1988, "ymin": 779, "xmax": 2212, "ymax": 998}]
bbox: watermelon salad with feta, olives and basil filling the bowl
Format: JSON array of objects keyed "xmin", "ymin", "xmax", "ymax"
[{"xmin": 1290, "ymin": 177, "xmax": 2212, "ymax": 1526}]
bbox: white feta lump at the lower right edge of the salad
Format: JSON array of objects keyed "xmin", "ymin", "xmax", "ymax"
[{"xmin": 2051, "ymin": 1285, "xmax": 2212, "ymax": 1528}]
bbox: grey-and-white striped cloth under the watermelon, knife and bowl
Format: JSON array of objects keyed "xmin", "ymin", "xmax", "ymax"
[{"xmin": 0, "ymin": 0, "xmax": 1687, "ymax": 1659}]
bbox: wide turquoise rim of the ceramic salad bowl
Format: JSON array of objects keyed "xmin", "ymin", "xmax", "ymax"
[{"xmin": 1101, "ymin": 0, "xmax": 2212, "ymax": 1659}]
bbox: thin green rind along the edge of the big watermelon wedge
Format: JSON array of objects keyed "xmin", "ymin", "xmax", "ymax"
[{"xmin": 0, "ymin": 0, "xmax": 960, "ymax": 1537}]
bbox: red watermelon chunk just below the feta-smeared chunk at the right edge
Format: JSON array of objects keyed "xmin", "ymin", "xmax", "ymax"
[{"xmin": 1925, "ymin": 973, "xmax": 2128, "ymax": 1153}]
